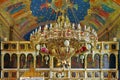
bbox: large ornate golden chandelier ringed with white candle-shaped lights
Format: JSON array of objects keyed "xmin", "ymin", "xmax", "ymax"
[{"xmin": 30, "ymin": 14, "xmax": 98, "ymax": 66}]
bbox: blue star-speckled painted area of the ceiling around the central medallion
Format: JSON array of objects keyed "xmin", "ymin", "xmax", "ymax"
[{"xmin": 30, "ymin": 0, "xmax": 90, "ymax": 23}]
